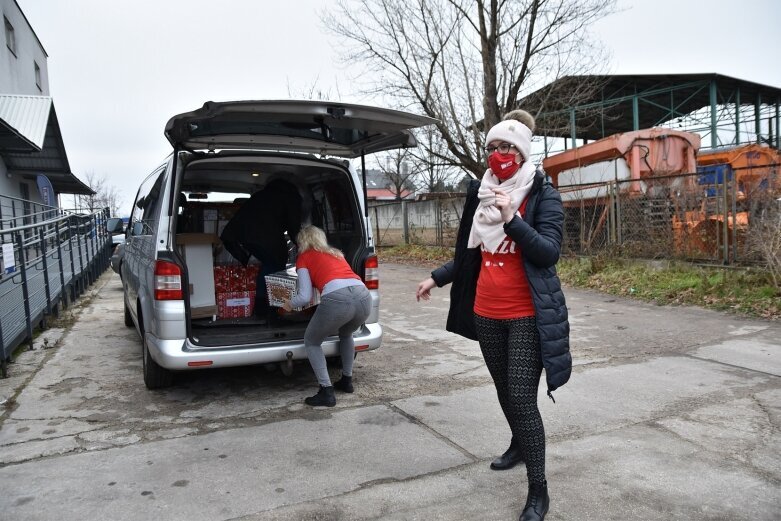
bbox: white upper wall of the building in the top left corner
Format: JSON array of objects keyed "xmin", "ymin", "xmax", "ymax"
[{"xmin": 0, "ymin": 0, "xmax": 49, "ymax": 96}]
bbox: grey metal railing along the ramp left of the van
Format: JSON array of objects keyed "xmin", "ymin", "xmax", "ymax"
[{"xmin": 0, "ymin": 207, "xmax": 112, "ymax": 377}]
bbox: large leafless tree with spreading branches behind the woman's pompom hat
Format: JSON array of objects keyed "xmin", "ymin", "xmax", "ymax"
[{"xmin": 324, "ymin": 0, "xmax": 615, "ymax": 177}]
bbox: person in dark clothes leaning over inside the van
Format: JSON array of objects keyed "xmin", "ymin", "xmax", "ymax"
[{"xmin": 220, "ymin": 179, "xmax": 302, "ymax": 320}]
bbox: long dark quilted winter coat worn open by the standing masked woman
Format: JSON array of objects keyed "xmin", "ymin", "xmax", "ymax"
[{"xmin": 431, "ymin": 171, "xmax": 572, "ymax": 394}]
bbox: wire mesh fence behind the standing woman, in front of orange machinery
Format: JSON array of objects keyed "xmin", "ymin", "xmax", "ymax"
[{"xmin": 370, "ymin": 165, "xmax": 781, "ymax": 263}]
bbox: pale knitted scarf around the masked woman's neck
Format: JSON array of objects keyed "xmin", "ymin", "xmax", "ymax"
[{"xmin": 467, "ymin": 161, "xmax": 535, "ymax": 253}]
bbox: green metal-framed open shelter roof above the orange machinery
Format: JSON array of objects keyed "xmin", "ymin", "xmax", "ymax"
[{"xmin": 518, "ymin": 73, "xmax": 781, "ymax": 155}]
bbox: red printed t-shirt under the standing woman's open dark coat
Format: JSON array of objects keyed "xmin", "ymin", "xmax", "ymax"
[{"xmin": 474, "ymin": 201, "xmax": 535, "ymax": 319}]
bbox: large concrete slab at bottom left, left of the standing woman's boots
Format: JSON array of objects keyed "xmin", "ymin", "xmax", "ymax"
[{"xmin": 0, "ymin": 406, "xmax": 473, "ymax": 521}]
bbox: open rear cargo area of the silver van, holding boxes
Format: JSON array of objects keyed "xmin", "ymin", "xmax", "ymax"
[{"xmin": 174, "ymin": 152, "xmax": 369, "ymax": 347}]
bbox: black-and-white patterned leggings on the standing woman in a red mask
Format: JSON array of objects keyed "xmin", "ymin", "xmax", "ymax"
[{"xmin": 475, "ymin": 315, "xmax": 545, "ymax": 484}]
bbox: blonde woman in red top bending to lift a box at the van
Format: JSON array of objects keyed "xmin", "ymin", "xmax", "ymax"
[{"xmin": 282, "ymin": 225, "xmax": 372, "ymax": 407}]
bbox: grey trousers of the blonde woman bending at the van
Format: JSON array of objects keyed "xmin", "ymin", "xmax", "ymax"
[{"xmin": 304, "ymin": 285, "xmax": 372, "ymax": 387}]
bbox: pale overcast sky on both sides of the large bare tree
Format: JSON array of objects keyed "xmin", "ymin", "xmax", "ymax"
[{"xmin": 17, "ymin": 0, "xmax": 781, "ymax": 213}]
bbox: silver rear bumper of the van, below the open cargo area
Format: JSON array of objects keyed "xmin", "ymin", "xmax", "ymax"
[{"xmin": 146, "ymin": 322, "xmax": 382, "ymax": 371}]
